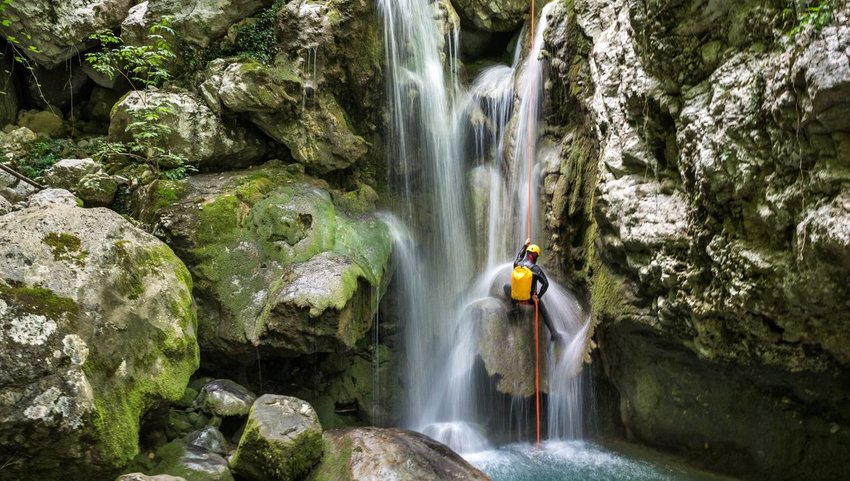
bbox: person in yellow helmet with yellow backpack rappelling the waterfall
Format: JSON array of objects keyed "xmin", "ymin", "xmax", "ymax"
[{"xmin": 505, "ymin": 239, "xmax": 561, "ymax": 341}]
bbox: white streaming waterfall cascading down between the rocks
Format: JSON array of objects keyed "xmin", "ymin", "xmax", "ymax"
[{"xmin": 379, "ymin": 0, "xmax": 587, "ymax": 452}]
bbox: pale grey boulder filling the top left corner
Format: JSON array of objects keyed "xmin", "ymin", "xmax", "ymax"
[{"xmin": 0, "ymin": 0, "xmax": 134, "ymax": 68}]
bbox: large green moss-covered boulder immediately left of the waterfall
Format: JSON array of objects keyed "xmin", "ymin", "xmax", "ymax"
[{"xmin": 142, "ymin": 166, "xmax": 392, "ymax": 362}]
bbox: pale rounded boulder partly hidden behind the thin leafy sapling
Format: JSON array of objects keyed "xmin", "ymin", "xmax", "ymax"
[{"xmin": 109, "ymin": 90, "xmax": 266, "ymax": 169}]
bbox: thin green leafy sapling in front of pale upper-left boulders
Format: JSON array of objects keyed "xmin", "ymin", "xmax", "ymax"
[{"xmin": 86, "ymin": 17, "xmax": 194, "ymax": 178}]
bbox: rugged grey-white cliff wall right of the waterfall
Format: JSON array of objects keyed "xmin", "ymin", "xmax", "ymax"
[{"xmin": 546, "ymin": 0, "xmax": 850, "ymax": 479}]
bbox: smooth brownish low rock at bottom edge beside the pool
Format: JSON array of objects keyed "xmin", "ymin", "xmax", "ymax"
[{"xmin": 308, "ymin": 428, "xmax": 490, "ymax": 481}]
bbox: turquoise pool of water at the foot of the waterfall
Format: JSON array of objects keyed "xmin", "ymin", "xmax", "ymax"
[{"xmin": 463, "ymin": 440, "xmax": 734, "ymax": 481}]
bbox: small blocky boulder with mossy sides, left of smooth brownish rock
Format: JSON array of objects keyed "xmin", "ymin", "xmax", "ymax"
[{"xmin": 230, "ymin": 394, "xmax": 324, "ymax": 481}]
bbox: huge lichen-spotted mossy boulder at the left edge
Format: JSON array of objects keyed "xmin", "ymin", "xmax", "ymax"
[{"xmin": 0, "ymin": 205, "xmax": 198, "ymax": 480}]
